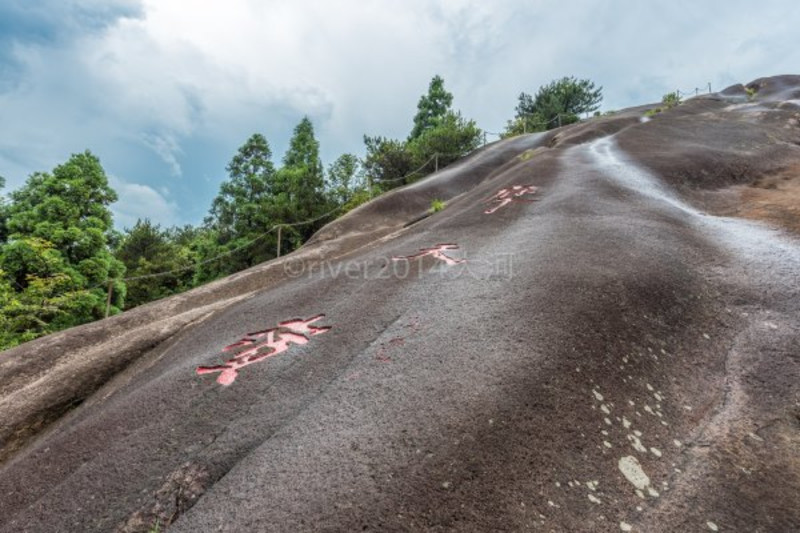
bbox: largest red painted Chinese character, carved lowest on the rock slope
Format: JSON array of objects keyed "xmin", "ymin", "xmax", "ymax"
[{"xmin": 197, "ymin": 315, "xmax": 331, "ymax": 385}]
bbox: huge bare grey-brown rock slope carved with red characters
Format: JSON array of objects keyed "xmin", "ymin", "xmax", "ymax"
[{"xmin": 0, "ymin": 76, "xmax": 800, "ymax": 532}]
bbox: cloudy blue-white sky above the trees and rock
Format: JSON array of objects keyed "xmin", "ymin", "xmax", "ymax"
[{"xmin": 0, "ymin": 0, "xmax": 800, "ymax": 229}]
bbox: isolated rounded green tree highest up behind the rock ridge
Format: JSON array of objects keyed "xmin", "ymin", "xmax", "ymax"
[{"xmin": 504, "ymin": 76, "xmax": 603, "ymax": 137}]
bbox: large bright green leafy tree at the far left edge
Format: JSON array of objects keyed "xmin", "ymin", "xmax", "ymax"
[{"xmin": 0, "ymin": 151, "xmax": 125, "ymax": 347}]
